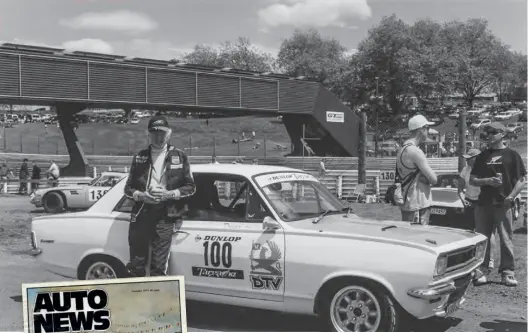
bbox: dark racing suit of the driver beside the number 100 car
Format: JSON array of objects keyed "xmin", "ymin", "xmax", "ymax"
[{"xmin": 124, "ymin": 145, "xmax": 196, "ymax": 276}]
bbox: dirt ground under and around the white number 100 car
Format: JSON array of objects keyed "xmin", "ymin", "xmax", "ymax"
[{"xmin": 0, "ymin": 195, "xmax": 528, "ymax": 332}]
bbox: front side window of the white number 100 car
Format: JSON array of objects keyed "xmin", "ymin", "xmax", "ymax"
[{"xmin": 185, "ymin": 174, "xmax": 269, "ymax": 223}]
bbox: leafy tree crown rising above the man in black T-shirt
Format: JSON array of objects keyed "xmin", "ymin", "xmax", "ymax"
[{"xmin": 441, "ymin": 19, "xmax": 505, "ymax": 107}]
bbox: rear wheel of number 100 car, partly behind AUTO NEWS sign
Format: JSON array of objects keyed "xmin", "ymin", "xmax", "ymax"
[{"xmin": 77, "ymin": 255, "xmax": 128, "ymax": 280}]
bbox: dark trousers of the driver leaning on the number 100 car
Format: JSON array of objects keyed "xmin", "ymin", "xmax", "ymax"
[{"xmin": 127, "ymin": 205, "xmax": 174, "ymax": 277}]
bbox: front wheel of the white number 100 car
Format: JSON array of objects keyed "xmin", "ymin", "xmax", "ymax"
[{"xmin": 319, "ymin": 281, "xmax": 400, "ymax": 332}]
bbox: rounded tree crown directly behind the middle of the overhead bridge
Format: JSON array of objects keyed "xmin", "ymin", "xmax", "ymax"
[{"xmin": 277, "ymin": 29, "xmax": 347, "ymax": 90}]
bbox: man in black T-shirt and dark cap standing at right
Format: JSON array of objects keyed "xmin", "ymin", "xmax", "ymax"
[{"xmin": 469, "ymin": 122, "xmax": 526, "ymax": 287}]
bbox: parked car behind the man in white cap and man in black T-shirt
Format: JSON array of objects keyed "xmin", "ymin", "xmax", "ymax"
[{"xmin": 430, "ymin": 173, "xmax": 521, "ymax": 229}]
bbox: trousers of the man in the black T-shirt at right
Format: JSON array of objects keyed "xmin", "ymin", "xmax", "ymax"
[{"xmin": 475, "ymin": 205, "xmax": 515, "ymax": 275}]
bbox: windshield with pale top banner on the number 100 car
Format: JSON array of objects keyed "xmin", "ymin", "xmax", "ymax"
[{"xmin": 255, "ymin": 172, "xmax": 347, "ymax": 221}]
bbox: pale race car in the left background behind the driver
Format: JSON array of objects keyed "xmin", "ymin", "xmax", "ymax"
[{"xmin": 29, "ymin": 171, "xmax": 127, "ymax": 213}]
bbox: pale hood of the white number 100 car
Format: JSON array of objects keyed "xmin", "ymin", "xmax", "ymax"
[{"xmin": 288, "ymin": 213, "xmax": 479, "ymax": 254}]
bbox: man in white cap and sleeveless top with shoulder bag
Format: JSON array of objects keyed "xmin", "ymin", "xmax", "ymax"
[{"xmin": 396, "ymin": 115, "xmax": 437, "ymax": 225}]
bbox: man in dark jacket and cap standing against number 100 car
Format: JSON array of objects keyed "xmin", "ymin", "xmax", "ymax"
[{"xmin": 125, "ymin": 115, "xmax": 196, "ymax": 277}]
